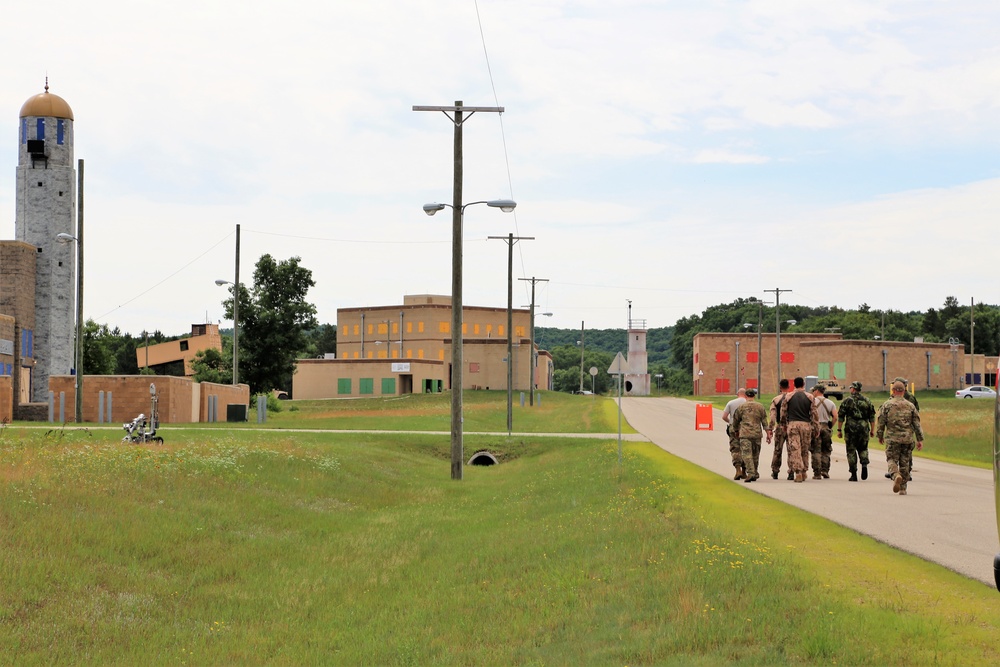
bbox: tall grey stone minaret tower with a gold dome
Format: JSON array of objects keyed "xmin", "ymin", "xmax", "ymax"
[{"xmin": 14, "ymin": 77, "xmax": 76, "ymax": 402}]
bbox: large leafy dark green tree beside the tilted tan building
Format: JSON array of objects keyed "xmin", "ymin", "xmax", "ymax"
[{"xmin": 222, "ymin": 254, "xmax": 317, "ymax": 394}]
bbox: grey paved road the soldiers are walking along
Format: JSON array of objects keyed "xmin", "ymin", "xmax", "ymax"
[{"xmin": 622, "ymin": 398, "xmax": 1000, "ymax": 586}]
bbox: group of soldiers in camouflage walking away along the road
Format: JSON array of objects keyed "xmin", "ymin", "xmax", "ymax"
[{"xmin": 722, "ymin": 377, "xmax": 924, "ymax": 495}]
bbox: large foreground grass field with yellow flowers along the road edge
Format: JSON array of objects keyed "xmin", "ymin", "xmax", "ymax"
[{"xmin": 0, "ymin": 428, "xmax": 1000, "ymax": 665}]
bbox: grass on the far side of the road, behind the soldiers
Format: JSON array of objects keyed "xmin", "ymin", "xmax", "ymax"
[{"xmin": 692, "ymin": 390, "xmax": 996, "ymax": 468}]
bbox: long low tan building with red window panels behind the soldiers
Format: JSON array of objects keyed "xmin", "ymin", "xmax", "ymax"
[{"xmin": 692, "ymin": 333, "xmax": 997, "ymax": 396}]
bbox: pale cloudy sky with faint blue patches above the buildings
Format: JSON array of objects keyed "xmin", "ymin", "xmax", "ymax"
[{"xmin": 0, "ymin": 0, "xmax": 1000, "ymax": 335}]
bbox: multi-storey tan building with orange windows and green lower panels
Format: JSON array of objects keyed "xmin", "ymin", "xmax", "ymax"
[{"xmin": 292, "ymin": 294, "xmax": 552, "ymax": 399}]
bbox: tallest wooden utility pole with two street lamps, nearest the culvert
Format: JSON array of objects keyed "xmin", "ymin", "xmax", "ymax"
[{"xmin": 424, "ymin": 196, "xmax": 517, "ymax": 480}]
